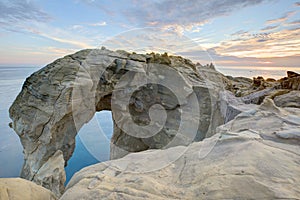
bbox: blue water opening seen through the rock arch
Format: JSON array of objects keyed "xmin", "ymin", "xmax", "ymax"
[{"xmin": 65, "ymin": 109, "xmax": 113, "ymax": 185}]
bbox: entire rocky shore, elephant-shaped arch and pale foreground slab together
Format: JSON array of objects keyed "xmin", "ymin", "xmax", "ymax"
[{"xmin": 0, "ymin": 48, "xmax": 300, "ymax": 199}]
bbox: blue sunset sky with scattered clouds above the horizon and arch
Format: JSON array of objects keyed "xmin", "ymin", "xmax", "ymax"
[{"xmin": 0, "ymin": 0, "xmax": 300, "ymax": 68}]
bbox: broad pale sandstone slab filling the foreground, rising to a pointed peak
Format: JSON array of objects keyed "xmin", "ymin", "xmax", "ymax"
[{"xmin": 61, "ymin": 98, "xmax": 300, "ymax": 200}]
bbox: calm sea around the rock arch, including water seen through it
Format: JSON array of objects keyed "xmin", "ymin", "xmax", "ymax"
[{"xmin": 0, "ymin": 66, "xmax": 300, "ymax": 182}]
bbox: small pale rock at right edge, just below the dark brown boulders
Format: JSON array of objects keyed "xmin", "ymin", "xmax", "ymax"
[{"xmin": 274, "ymin": 91, "xmax": 300, "ymax": 108}]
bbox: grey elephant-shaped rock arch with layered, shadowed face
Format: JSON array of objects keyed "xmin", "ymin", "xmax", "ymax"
[{"xmin": 10, "ymin": 49, "xmax": 227, "ymax": 196}]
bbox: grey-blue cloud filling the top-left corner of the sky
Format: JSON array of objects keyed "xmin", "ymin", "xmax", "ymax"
[{"xmin": 0, "ymin": 0, "xmax": 51, "ymax": 28}]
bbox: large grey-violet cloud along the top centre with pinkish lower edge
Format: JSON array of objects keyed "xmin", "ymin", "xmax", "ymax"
[{"xmin": 81, "ymin": 0, "xmax": 269, "ymax": 32}]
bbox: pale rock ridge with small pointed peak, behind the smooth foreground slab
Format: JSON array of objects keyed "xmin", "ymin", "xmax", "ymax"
[{"xmin": 218, "ymin": 98, "xmax": 300, "ymax": 147}]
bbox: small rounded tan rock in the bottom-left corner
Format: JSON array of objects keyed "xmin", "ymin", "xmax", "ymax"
[{"xmin": 0, "ymin": 178, "xmax": 57, "ymax": 200}]
